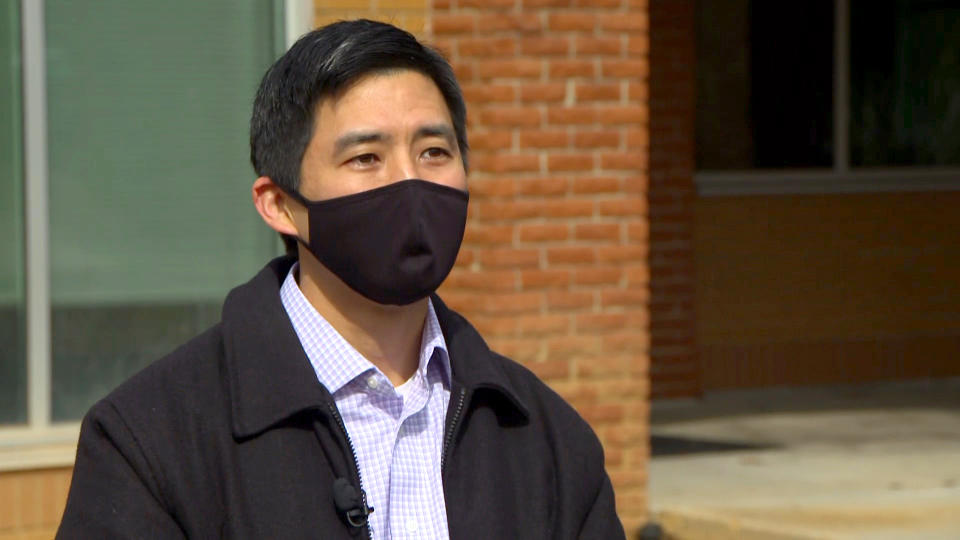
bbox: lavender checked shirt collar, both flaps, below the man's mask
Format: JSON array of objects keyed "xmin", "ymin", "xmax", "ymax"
[{"xmin": 280, "ymin": 264, "xmax": 450, "ymax": 394}]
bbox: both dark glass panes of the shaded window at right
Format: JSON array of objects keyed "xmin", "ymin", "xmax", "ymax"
[{"xmin": 696, "ymin": 0, "xmax": 960, "ymax": 172}]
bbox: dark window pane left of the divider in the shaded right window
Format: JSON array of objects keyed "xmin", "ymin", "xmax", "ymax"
[{"xmin": 696, "ymin": 0, "xmax": 834, "ymax": 170}]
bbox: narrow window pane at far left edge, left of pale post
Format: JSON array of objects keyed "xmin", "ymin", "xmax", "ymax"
[{"xmin": 0, "ymin": 2, "xmax": 27, "ymax": 424}]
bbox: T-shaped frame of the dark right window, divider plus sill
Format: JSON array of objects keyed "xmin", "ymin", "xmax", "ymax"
[{"xmin": 693, "ymin": 0, "xmax": 960, "ymax": 197}]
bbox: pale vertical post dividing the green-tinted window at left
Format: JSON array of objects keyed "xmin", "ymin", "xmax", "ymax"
[{"xmin": 20, "ymin": 0, "xmax": 51, "ymax": 429}]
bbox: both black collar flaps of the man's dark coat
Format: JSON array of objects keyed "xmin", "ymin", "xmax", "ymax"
[{"xmin": 222, "ymin": 257, "xmax": 528, "ymax": 438}]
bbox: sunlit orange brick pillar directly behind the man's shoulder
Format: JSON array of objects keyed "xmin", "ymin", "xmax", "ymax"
[{"xmin": 429, "ymin": 0, "xmax": 650, "ymax": 531}]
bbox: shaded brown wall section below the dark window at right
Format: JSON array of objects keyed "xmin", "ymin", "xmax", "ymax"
[{"xmin": 695, "ymin": 192, "xmax": 960, "ymax": 390}]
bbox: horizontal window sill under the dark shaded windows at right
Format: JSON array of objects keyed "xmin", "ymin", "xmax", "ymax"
[{"xmin": 694, "ymin": 167, "xmax": 960, "ymax": 197}]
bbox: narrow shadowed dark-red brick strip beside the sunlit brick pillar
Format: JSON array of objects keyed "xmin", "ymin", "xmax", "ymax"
[{"xmin": 649, "ymin": 0, "xmax": 702, "ymax": 398}]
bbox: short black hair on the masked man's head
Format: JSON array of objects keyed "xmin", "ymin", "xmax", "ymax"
[{"xmin": 250, "ymin": 19, "xmax": 468, "ymax": 254}]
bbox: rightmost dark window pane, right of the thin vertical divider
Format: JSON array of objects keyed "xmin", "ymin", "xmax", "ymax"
[{"xmin": 850, "ymin": 0, "xmax": 960, "ymax": 166}]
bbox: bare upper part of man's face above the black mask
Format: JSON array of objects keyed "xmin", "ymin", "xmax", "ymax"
[{"xmin": 295, "ymin": 70, "xmax": 467, "ymax": 205}]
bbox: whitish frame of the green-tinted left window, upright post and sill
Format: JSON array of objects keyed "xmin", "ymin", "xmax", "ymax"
[{"xmin": 0, "ymin": 0, "xmax": 314, "ymax": 471}]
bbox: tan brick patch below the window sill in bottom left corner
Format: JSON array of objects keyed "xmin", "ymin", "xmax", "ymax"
[{"xmin": 0, "ymin": 467, "xmax": 72, "ymax": 540}]
